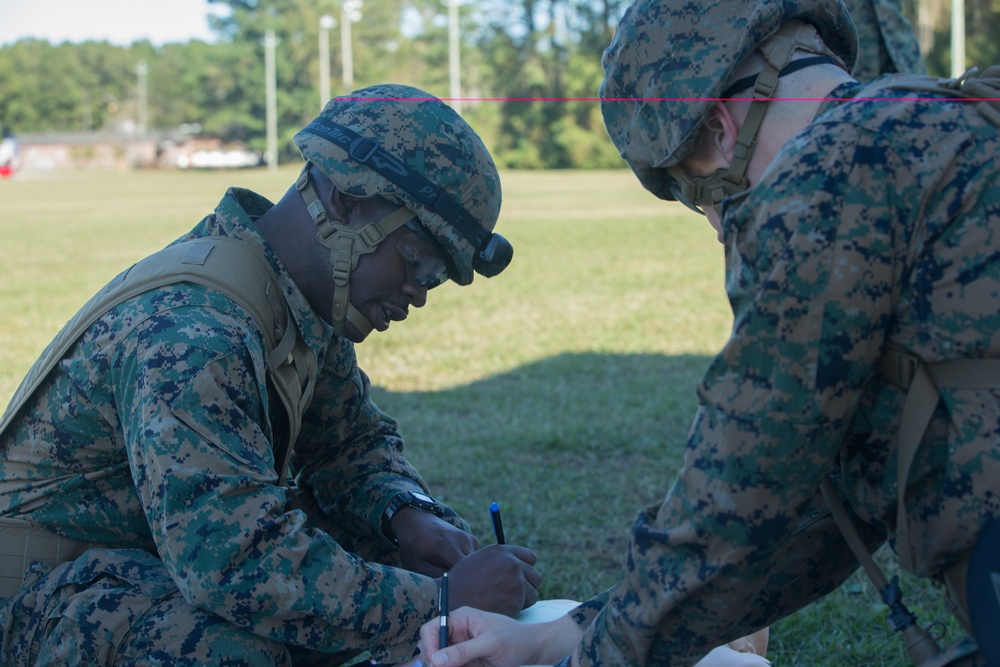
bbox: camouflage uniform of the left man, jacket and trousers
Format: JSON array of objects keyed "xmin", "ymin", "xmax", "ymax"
[{"xmin": 0, "ymin": 189, "xmax": 464, "ymax": 665}]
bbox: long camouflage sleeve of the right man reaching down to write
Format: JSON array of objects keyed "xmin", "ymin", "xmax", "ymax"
[{"xmin": 577, "ymin": 128, "xmax": 920, "ymax": 665}]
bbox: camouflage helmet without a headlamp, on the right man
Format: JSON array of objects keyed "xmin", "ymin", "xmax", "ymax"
[{"xmin": 600, "ymin": 0, "xmax": 858, "ymax": 205}]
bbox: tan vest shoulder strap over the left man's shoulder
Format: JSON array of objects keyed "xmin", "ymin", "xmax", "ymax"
[{"xmin": 0, "ymin": 237, "xmax": 316, "ymax": 482}]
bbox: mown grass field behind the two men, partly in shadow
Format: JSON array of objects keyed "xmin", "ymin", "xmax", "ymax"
[{"xmin": 0, "ymin": 168, "xmax": 968, "ymax": 667}]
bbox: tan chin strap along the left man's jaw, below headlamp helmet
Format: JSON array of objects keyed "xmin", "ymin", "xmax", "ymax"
[{"xmin": 295, "ymin": 162, "xmax": 415, "ymax": 338}]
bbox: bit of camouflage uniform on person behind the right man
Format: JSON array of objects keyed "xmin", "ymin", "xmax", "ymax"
[{"xmin": 845, "ymin": 0, "xmax": 926, "ymax": 81}]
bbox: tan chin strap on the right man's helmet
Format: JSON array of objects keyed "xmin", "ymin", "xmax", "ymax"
[{"xmin": 667, "ymin": 22, "xmax": 846, "ymax": 206}]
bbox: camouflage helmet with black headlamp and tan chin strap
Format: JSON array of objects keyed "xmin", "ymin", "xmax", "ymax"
[{"xmin": 295, "ymin": 84, "xmax": 513, "ymax": 331}]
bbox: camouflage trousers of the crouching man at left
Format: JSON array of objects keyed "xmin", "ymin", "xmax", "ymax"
[{"xmin": 0, "ymin": 498, "xmax": 448, "ymax": 667}]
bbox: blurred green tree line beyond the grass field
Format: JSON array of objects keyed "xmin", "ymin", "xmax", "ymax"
[{"xmin": 0, "ymin": 0, "xmax": 1000, "ymax": 168}]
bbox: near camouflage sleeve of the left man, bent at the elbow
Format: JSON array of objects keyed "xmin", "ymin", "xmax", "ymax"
[{"xmin": 111, "ymin": 304, "xmax": 436, "ymax": 664}]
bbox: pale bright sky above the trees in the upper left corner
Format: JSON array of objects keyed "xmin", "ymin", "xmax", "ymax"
[{"xmin": 0, "ymin": 0, "xmax": 219, "ymax": 46}]
